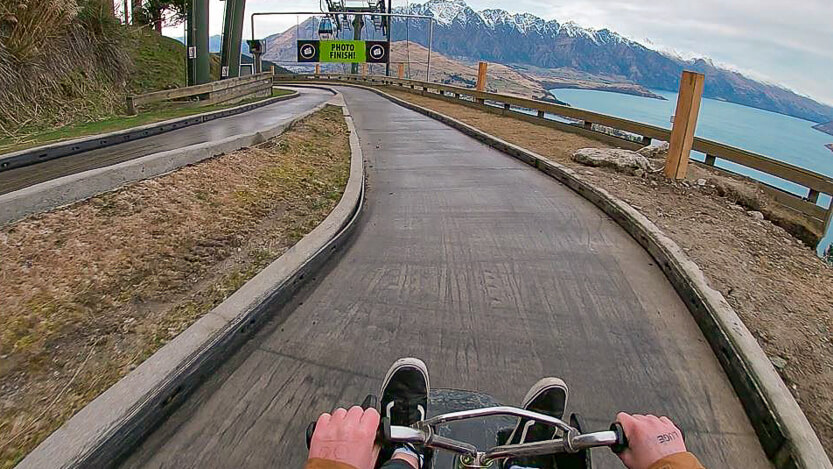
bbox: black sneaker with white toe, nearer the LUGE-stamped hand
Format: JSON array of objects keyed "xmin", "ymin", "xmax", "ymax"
[{"xmin": 503, "ymin": 378, "xmax": 567, "ymax": 468}]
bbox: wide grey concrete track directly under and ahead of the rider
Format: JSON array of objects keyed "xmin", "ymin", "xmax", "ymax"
[{"xmin": 125, "ymin": 88, "xmax": 769, "ymax": 467}]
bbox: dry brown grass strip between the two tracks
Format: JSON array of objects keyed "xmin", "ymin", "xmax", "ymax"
[{"xmin": 0, "ymin": 106, "xmax": 350, "ymax": 468}]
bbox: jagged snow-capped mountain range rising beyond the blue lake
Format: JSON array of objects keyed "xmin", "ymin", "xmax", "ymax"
[{"xmin": 392, "ymin": 0, "xmax": 833, "ymax": 122}]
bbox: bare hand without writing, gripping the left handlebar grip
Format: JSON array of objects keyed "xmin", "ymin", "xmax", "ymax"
[{"xmin": 309, "ymin": 406, "xmax": 380, "ymax": 469}]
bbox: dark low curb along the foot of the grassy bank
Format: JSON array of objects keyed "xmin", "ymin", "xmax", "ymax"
[{"xmin": 0, "ymin": 88, "xmax": 300, "ymax": 171}]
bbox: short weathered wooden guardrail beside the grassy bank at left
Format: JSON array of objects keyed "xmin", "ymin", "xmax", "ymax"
[{"xmin": 127, "ymin": 72, "xmax": 272, "ymax": 115}]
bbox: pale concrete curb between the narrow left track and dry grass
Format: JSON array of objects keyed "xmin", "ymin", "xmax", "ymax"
[{"xmin": 0, "ymin": 90, "xmax": 332, "ymax": 226}]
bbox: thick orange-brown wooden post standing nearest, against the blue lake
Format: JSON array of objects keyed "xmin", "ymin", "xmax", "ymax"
[{"xmin": 665, "ymin": 71, "xmax": 706, "ymax": 179}]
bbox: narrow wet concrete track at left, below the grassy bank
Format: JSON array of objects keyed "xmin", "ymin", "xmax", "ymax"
[{"xmin": 0, "ymin": 88, "xmax": 332, "ymax": 194}]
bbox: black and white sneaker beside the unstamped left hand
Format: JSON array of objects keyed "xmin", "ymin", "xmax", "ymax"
[{"xmin": 379, "ymin": 358, "xmax": 430, "ymax": 467}]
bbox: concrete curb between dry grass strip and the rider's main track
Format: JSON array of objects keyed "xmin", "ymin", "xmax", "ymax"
[{"xmin": 17, "ymin": 89, "xmax": 364, "ymax": 468}]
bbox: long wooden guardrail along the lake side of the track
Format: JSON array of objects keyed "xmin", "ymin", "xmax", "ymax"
[{"xmin": 274, "ymin": 74, "xmax": 833, "ymax": 233}]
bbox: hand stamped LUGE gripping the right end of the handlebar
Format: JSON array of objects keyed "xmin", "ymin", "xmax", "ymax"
[{"xmin": 616, "ymin": 412, "xmax": 686, "ymax": 469}]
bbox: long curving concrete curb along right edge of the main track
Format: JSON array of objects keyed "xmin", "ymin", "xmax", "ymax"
[{"xmin": 344, "ymin": 84, "xmax": 833, "ymax": 469}]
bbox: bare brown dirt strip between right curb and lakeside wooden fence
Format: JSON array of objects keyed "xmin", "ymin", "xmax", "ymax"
[{"xmin": 385, "ymin": 89, "xmax": 833, "ymax": 457}]
